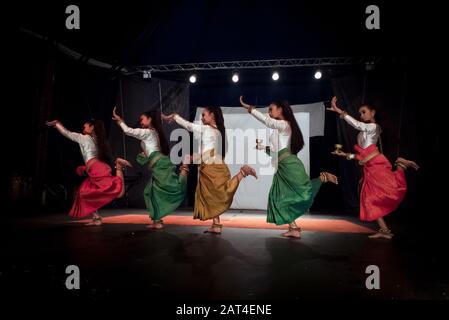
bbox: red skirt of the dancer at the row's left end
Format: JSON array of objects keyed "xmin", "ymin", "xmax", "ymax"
[{"xmin": 69, "ymin": 159, "xmax": 122, "ymax": 218}]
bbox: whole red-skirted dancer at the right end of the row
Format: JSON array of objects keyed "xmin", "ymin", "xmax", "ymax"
[{"xmin": 327, "ymin": 97, "xmax": 419, "ymax": 239}]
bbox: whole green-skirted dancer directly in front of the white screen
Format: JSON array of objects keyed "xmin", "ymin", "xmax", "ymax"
[{"xmin": 240, "ymin": 97, "xmax": 338, "ymax": 238}]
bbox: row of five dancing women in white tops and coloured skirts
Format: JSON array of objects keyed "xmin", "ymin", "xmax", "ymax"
[{"xmin": 47, "ymin": 97, "xmax": 418, "ymax": 239}]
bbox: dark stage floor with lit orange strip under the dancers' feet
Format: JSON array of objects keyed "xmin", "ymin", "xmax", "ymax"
[{"xmin": 0, "ymin": 210, "xmax": 449, "ymax": 303}]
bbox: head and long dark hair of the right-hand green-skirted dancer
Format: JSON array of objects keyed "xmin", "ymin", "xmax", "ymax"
[{"xmin": 268, "ymin": 101, "xmax": 304, "ymax": 154}]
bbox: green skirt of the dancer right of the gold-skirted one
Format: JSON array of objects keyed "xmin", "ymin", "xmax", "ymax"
[{"xmin": 267, "ymin": 148, "xmax": 321, "ymax": 225}]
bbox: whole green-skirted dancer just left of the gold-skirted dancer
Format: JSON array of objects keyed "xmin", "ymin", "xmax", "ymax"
[{"xmin": 112, "ymin": 108, "xmax": 190, "ymax": 229}]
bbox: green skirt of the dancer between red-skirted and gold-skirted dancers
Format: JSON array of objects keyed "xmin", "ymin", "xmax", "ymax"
[{"xmin": 137, "ymin": 151, "xmax": 187, "ymax": 221}]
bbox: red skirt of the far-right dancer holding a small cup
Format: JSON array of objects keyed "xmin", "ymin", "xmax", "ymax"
[{"xmin": 354, "ymin": 144, "xmax": 407, "ymax": 221}]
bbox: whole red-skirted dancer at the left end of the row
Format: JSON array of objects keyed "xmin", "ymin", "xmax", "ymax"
[{"xmin": 47, "ymin": 120, "xmax": 131, "ymax": 225}]
